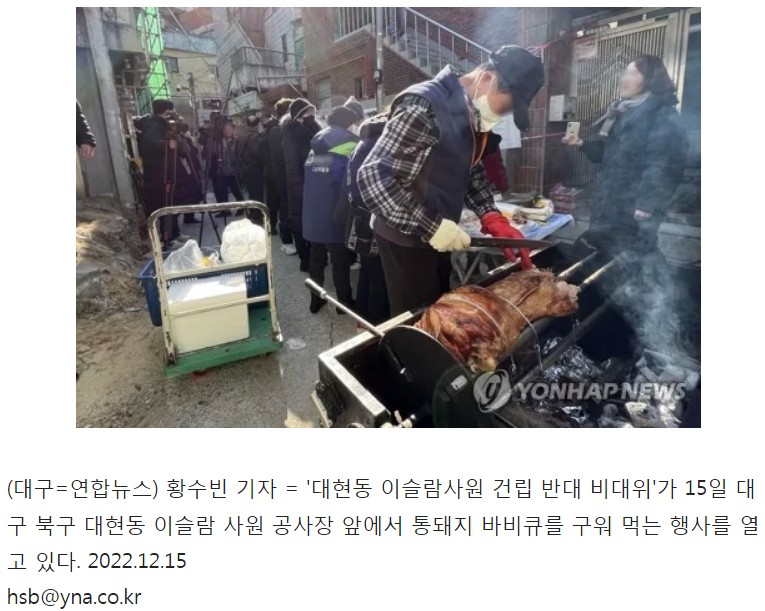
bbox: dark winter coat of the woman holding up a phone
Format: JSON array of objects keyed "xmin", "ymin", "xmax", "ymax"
[{"xmin": 581, "ymin": 94, "xmax": 687, "ymax": 235}]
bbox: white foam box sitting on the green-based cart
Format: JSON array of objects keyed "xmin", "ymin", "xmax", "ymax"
[{"xmin": 167, "ymin": 274, "xmax": 250, "ymax": 352}]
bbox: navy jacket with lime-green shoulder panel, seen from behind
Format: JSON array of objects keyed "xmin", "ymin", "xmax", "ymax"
[{"xmin": 303, "ymin": 126, "xmax": 359, "ymax": 244}]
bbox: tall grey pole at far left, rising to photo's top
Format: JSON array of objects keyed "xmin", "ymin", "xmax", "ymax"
[{"xmin": 85, "ymin": 7, "xmax": 135, "ymax": 208}]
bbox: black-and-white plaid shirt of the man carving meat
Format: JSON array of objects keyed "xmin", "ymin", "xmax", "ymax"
[{"xmin": 357, "ymin": 95, "xmax": 496, "ymax": 241}]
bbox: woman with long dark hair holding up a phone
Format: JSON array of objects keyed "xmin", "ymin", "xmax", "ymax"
[{"xmin": 563, "ymin": 55, "xmax": 687, "ymax": 250}]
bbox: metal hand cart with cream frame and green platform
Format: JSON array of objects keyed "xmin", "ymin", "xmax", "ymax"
[{"xmin": 148, "ymin": 201, "xmax": 282, "ymax": 377}]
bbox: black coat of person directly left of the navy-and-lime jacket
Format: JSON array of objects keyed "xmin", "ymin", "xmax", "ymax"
[{"xmin": 281, "ymin": 114, "xmax": 319, "ymax": 233}]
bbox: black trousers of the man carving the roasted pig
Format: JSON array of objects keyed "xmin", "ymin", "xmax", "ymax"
[{"xmin": 375, "ymin": 234, "xmax": 452, "ymax": 316}]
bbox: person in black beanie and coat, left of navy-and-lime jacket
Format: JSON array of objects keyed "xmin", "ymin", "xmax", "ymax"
[{"xmin": 281, "ymin": 98, "xmax": 319, "ymax": 272}]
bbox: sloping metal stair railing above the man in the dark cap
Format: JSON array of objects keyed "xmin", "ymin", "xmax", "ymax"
[{"xmin": 383, "ymin": 7, "xmax": 491, "ymax": 72}]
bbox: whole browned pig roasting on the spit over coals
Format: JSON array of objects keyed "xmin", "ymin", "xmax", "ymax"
[{"xmin": 415, "ymin": 269, "xmax": 578, "ymax": 372}]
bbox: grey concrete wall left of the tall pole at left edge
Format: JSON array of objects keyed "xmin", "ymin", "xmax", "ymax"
[{"xmin": 77, "ymin": 47, "xmax": 116, "ymax": 196}]
